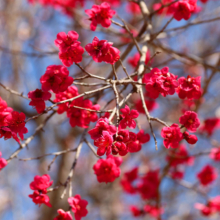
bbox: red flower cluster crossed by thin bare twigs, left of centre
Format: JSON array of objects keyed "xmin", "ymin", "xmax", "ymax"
[{"xmin": 54, "ymin": 86, "xmax": 99, "ymax": 128}]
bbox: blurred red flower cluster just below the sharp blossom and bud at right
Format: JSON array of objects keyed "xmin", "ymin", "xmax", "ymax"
[{"xmin": 166, "ymin": 145, "xmax": 194, "ymax": 167}]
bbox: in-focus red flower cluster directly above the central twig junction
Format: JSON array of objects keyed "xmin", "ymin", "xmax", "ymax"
[{"xmin": 85, "ymin": 37, "xmax": 120, "ymax": 64}]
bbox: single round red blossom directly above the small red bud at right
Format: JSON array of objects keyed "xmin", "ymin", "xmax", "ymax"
[{"xmin": 179, "ymin": 111, "xmax": 200, "ymax": 132}]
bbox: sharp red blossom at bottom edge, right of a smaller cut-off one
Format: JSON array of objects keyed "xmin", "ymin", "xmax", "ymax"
[{"xmin": 68, "ymin": 195, "xmax": 88, "ymax": 220}]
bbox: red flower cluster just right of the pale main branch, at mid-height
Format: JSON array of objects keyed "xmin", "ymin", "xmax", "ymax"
[{"xmin": 143, "ymin": 67, "xmax": 178, "ymax": 99}]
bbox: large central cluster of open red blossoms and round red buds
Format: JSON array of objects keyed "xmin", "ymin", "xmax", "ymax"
[{"xmin": 88, "ymin": 118, "xmax": 150, "ymax": 156}]
